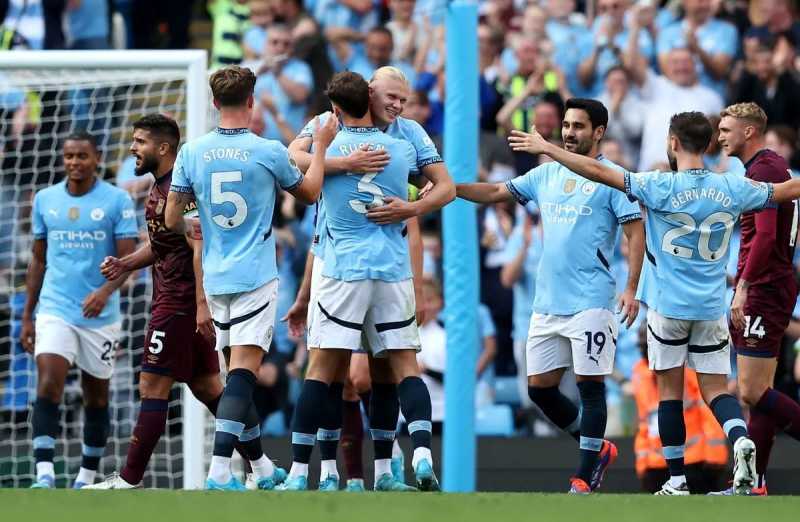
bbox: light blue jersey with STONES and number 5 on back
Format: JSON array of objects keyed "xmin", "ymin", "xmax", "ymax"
[{"xmin": 170, "ymin": 128, "xmax": 303, "ymax": 295}]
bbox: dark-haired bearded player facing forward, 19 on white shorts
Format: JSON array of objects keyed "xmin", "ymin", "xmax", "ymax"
[{"xmin": 457, "ymin": 98, "xmax": 644, "ymax": 493}]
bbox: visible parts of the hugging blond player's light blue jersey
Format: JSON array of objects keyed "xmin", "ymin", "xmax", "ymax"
[{"xmin": 297, "ymin": 112, "xmax": 444, "ymax": 257}]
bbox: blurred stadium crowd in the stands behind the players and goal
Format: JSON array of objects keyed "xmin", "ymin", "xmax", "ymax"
[{"xmin": 0, "ymin": 0, "xmax": 800, "ymax": 483}]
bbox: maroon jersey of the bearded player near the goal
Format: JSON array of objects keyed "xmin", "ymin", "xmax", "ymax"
[{"xmin": 145, "ymin": 171, "xmax": 197, "ymax": 319}]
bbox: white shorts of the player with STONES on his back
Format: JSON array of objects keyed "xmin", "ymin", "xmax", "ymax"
[{"xmin": 207, "ymin": 278, "xmax": 278, "ymax": 352}]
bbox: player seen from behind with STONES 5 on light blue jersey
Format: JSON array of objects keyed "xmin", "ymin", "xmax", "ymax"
[{"xmin": 165, "ymin": 66, "xmax": 336, "ymax": 490}]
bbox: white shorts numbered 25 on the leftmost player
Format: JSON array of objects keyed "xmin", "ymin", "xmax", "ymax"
[{"xmin": 34, "ymin": 314, "xmax": 122, "ymax": 379}]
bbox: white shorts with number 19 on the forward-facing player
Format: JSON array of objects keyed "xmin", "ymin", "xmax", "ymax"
[{"xmin": 525, "ymin": 308, "xmax": 618, "ymax": 376}]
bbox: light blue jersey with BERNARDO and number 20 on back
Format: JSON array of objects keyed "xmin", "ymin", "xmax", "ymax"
[{"xmin": 625, "ymin": 169, "xmax": 772, "ymax": 321}]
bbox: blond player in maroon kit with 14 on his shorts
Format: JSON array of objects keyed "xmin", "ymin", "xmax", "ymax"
[{"xmin": 719, "ymin": 103, "xmax": 800, "ymax": 495}]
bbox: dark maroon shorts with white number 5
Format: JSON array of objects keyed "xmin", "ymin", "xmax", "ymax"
[{"xmin": 142, "ymin": 308, "xmax": 219, "ymax": 382}]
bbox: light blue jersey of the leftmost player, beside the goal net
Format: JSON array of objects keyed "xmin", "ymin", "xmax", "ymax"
[{"xmin": 31, "ymin": 179, "xmax": 139, "ymax": 328}]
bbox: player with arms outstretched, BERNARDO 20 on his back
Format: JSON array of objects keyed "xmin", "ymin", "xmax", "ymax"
[{"xmin": 509, "ymin": 106, "xmax": 800, "ymax": 495}]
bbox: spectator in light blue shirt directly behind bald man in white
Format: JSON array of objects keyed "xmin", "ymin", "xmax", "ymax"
[{"xmin": 657, "ymin": 0, "xmax": 739, "ymax": 97}]
